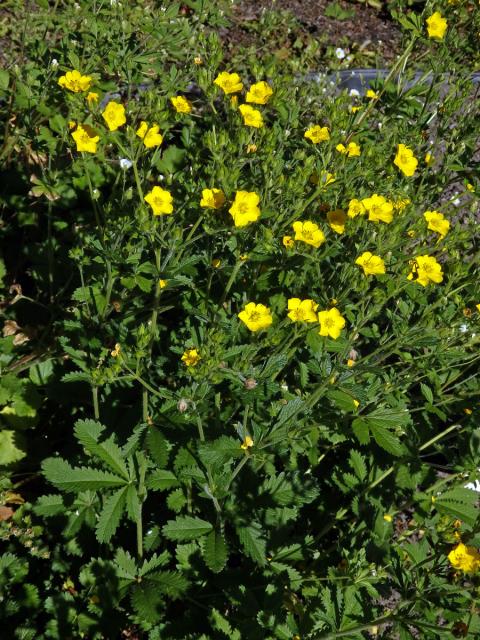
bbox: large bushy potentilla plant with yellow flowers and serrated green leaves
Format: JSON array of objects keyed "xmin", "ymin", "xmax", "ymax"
[{"xmin": 0, "ymin": 0, "xmax": 480, "ymax": 640}]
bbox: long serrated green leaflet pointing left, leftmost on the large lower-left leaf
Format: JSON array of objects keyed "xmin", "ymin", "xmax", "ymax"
[{"xmin": 42, "ymin": 458, "xmax": 125, "ymax": 493}]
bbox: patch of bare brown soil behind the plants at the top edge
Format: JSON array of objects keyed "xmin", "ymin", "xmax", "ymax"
[{"xmin": 222, "ymin": 0, "xmax": 401, "ymax": 63}]
